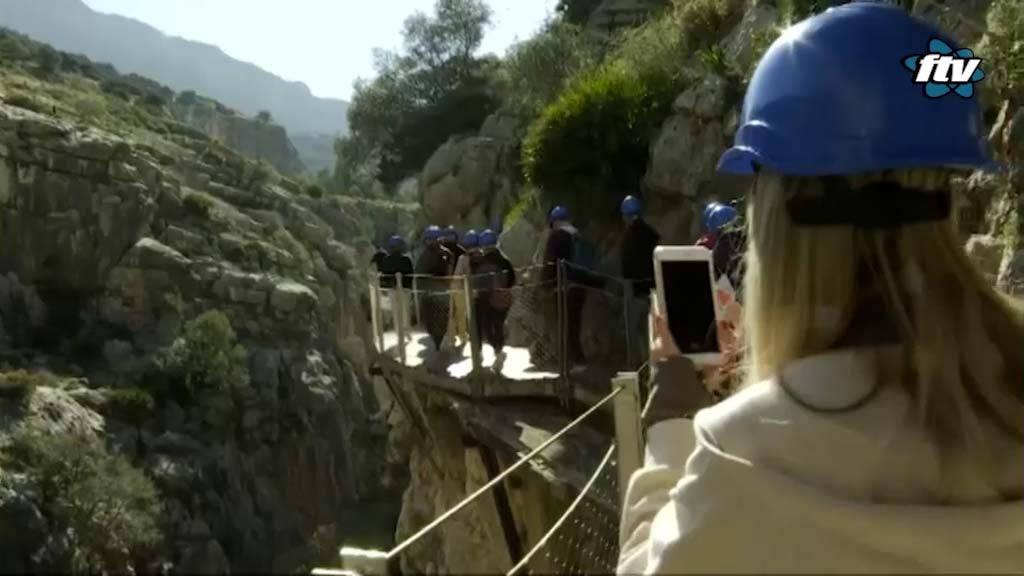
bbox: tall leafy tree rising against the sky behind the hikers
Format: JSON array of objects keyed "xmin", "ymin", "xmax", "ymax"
[{"xmin": 335, "ymin": 0, "xmax": 498, "ymax": 192}]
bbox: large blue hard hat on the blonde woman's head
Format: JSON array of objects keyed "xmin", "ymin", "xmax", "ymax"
[{"xmin": 718, "ymin": 2, "xmax": 992, "ymax": 176}]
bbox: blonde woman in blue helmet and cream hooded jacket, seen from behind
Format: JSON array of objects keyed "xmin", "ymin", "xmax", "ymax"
[{"xmin": 620, "ymin": 2, "xmax": 1024, "ymax": 574}]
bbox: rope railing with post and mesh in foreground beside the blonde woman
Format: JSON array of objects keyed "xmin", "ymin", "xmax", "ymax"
[{"xmin": 313, "ymin": 372, "xmax": 641, "ymax": 576}]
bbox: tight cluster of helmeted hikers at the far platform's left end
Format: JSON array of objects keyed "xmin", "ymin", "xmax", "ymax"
[{"xmin": 373, "ymin": 224, "xmax": 516, "ymax": 372}]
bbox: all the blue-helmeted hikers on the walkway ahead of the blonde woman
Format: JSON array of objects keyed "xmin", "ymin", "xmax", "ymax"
[{"xmin": 374, "ymin": 190, "xmax": 742, "ymax": 371}]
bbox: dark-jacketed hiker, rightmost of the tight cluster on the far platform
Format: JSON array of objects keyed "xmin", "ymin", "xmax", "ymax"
[{"xmin": 473, "ymin": 230, "xmax": 516, "ymax": 374}]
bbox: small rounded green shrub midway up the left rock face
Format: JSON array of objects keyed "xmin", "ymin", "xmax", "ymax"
[{"xmin": 163, "ymin": 311, "xmax": 246, "ymax": 397}]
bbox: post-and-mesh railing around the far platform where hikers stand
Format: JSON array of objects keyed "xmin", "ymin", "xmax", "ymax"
[{"xmin": 370, "ymin": 262, "xmax": 648, "ymax": 403}]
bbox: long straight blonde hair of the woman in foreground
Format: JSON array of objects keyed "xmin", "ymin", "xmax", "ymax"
[{"xmin": 743, "ymin": 169, "xmax": 1024, "ymax": 446}]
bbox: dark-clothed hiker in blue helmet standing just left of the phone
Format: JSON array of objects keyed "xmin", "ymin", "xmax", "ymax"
[{"xmin": 621, "ymin": 196, "xmax": 662, "ymax": 368}]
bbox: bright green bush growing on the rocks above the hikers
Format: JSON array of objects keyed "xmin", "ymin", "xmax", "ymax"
[{"xmin": 522, "ymin": 0, "xmax": 744, "ymax": 219}]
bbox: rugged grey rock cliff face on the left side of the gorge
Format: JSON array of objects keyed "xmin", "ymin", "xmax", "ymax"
[{"xmin": 0, "ymin": 87, "xmax": 413, "ymax": 573}]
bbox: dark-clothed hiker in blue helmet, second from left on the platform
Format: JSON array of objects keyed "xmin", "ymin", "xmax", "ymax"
[{"xmin": 416, "ymin": 225, "xmax": 455, "ymax": 352}]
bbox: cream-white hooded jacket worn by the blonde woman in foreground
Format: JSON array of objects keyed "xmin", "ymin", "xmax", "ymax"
[{"xmin": 618, "ymin": 344, "xmax": 1024, "ymax": 574}]
